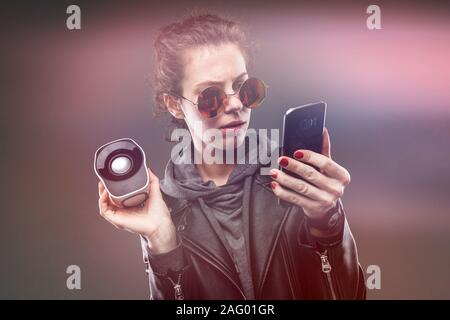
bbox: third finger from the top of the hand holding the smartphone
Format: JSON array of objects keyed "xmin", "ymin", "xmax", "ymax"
[{"xmin": 270, "ymin": 169, "xmax": 336, "ymax": 202}]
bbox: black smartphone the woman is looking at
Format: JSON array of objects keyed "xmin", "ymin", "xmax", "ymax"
[{"xmin": 281, "ymin": 101, "xmax": 327, "ymax": 179}]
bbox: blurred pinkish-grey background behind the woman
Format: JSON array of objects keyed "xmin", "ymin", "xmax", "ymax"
[{"xmin": 0, "ymin": 0, "xmax": 450, "ymax": 299}]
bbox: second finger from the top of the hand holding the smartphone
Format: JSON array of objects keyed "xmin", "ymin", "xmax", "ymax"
[{"xmin": 279, "ymin": 155, "xmax": 344, "ymax": 197}]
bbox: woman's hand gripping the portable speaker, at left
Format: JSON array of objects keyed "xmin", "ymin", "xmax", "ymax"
[{"xmin": 98, "ymin": 168, "xmax": 177, "ymax": 254}]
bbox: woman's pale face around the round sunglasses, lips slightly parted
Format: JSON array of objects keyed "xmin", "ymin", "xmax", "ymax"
[{"xmin": 181, "ymin": 43, "xmax": 250, "ymax": 149}]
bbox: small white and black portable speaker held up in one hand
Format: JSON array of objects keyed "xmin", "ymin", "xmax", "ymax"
[{"xmin": 94, "ymin": 138, "xmax": 149, "ymax": 208}]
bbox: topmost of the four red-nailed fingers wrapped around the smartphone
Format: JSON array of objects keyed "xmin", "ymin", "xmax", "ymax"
[{"xmin": 294, "ymin": 149, "xmax": 350, "ymax": 185}]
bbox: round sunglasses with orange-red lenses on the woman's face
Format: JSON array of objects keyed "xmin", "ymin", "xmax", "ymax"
[{"xmin": 173, "ymin": 78, "xmax": 268, "ymax": 118}]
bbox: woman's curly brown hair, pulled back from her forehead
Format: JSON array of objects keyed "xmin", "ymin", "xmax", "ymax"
[{"xmin": 153, "ymin": 11, "xmax": 255, "ymax": 127}]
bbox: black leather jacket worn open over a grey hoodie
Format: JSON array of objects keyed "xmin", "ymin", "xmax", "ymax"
[{"xmin": 141, "ymin": 175, "xmax": 366, "ymax": 299}]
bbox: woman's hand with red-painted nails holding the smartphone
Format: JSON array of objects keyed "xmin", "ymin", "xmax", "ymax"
[{"xmin": 271, "ymin": 128, "xmax": 350, "ymax": 219}]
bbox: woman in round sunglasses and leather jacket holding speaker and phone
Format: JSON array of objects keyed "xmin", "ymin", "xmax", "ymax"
[{"xmin": 99, "ymin": 14, "xmax": 365, "ymax": 299}]
